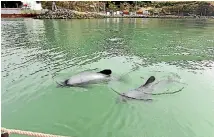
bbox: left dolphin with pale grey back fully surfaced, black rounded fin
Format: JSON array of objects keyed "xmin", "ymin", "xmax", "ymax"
[{"xmin": 56, "ymin": 69, "xmax": 112, "ymax": 87}]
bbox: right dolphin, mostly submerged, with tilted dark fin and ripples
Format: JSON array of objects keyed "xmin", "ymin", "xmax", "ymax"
[{"xmin": 111, "ymin": 76, "xmax": 183, "ymax": 101}]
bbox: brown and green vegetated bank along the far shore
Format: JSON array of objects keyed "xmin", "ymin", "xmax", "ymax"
[{"xmin": 42, "ymin": 1, "xmax": 214, "ymax": 16}]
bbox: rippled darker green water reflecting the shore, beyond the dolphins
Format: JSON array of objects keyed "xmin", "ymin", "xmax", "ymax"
[{"xmin": 2, "ymin": 18, "xmax": 214, "ymax": 78}]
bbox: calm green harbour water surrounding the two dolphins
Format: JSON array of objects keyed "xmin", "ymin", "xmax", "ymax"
[{"xmin": 1, "ymin": 19, "xmax": 214, "ymax": 137}]
